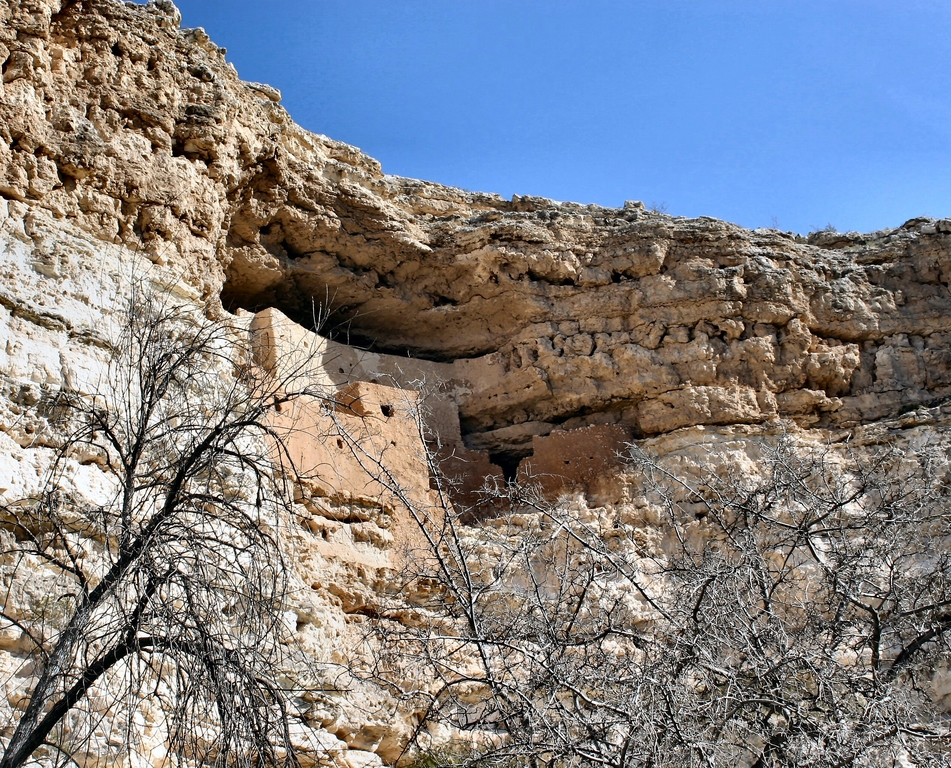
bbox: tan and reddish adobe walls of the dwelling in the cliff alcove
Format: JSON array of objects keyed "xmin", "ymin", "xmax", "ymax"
[{"xmin": 251, "ymin": 309, "xmax": 631, "ymax": 520}]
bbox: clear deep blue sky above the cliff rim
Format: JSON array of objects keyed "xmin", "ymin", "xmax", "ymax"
[{"xmin": 167, "ymin": 0, "xmax": 951, "ymax": 232}]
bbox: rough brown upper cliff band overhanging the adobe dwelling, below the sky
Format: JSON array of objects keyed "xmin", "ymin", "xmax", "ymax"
[{"xmin": 0, "ymin": 0, "xmax": 951, "ymax": 460}]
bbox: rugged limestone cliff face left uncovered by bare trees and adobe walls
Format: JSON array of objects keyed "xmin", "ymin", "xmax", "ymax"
[{"xmin": 0, "ymin": 0, "xmax": 951, "ymax": 765}]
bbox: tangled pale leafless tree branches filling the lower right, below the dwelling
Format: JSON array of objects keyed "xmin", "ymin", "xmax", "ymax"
[{"xmin": 376, "ymin": 439, "xmax": 951, "ymax": 768}]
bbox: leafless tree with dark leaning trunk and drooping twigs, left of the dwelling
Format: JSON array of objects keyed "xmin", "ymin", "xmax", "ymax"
[{"xmin": 0, "ymin": 285, "xmax": 319, "ymax": 768}]
